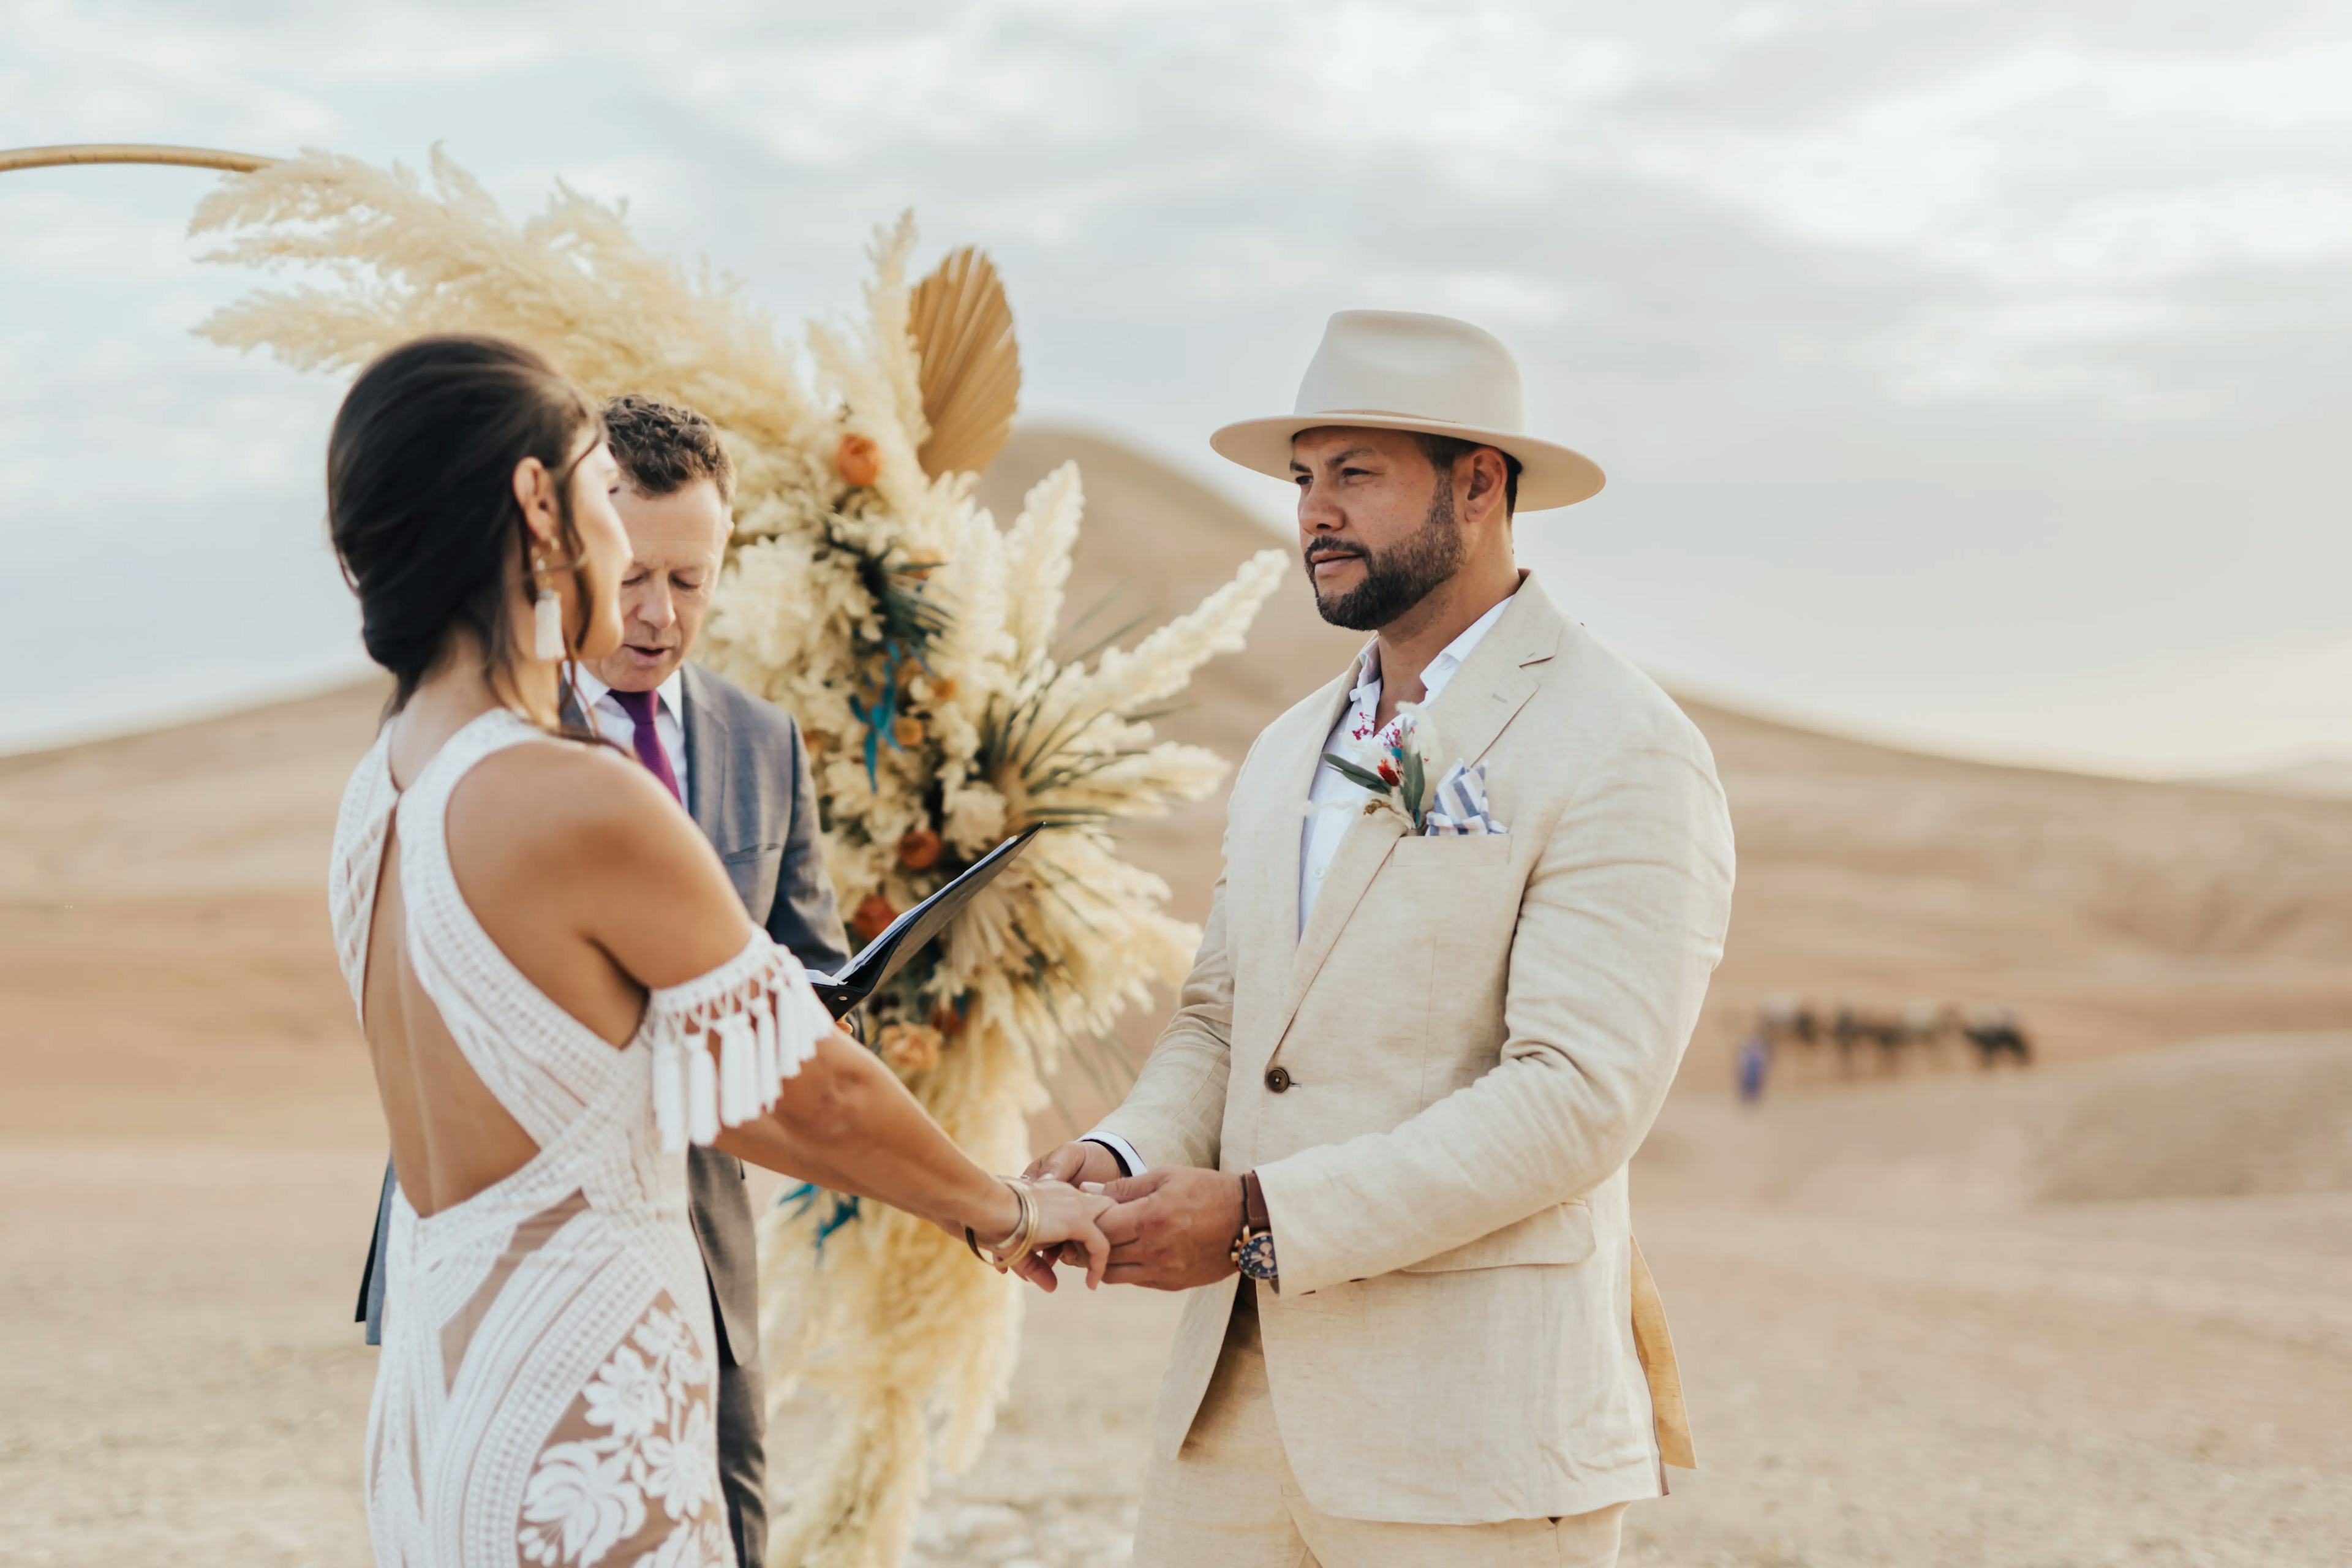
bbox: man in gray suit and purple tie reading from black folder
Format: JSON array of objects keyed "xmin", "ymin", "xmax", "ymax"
[{"xmin": 360, "ymin": 395, "xmax": 846, "ymax": 1568}]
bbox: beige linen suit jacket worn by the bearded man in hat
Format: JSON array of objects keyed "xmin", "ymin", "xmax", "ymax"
[{"xmin": 1103, "ymin": 576, "xmax": 1731, "ymax": 1523}]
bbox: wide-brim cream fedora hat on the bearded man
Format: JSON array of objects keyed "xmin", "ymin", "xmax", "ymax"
[{"xmin": 1209, "ymin": 311, "xmax": 1607, "ymax": 513}]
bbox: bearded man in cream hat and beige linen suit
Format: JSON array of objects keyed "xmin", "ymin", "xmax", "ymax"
[{"xmin": 1035, "ymin": 311, "xmax": 1731, "ymax": 1568}]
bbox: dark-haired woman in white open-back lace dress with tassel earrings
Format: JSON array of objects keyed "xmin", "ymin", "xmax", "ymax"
[{"xmin": 327, "ymin": 339, "xmax": 1108, "ymax": 1568}]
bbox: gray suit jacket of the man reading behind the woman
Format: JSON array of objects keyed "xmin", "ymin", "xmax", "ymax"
[{"xmin": 358, "ymin": 665, "xmax": 849, "ymax": 1366}]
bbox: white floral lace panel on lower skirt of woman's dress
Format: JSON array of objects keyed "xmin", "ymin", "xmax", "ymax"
[{"xmin": 515, "ymin": 1305, "xmax": 734, "ymax": 1568}]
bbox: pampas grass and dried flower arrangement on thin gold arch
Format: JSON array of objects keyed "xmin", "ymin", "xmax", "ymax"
[{"xmin": 0, "ymin": 146, "xmax": 1284, "ymax": 1568}]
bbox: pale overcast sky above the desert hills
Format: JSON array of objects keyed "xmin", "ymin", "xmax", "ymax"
[{"xmin": 0, "ymin": 0, "xmax": 2352, "ymax": 771}]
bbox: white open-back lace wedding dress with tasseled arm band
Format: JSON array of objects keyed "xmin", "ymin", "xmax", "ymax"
[{"xmin": 330, "ymin": 712, "xmax": 831, "ymax": 1568}]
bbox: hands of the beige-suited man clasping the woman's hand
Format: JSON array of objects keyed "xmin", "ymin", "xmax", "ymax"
[{"xmin": 1014, "ymin": 1142, "xmax": 1242, "ymax": 1291}]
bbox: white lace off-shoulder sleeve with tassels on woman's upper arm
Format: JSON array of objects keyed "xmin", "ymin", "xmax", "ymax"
[{"xmin": 647, "ymin": 931, "xmax": 832, "ymax": 1154}]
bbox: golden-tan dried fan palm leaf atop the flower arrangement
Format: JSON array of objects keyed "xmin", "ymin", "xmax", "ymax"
[{"xmin": 908, "ymin": 244, "xmax": 1021, "ymax": 480}]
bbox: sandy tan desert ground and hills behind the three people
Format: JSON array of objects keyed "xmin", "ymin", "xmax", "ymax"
[{"xmin": 0, "ymin": 435, "xmax": 2352, "ymax": 1568}]
